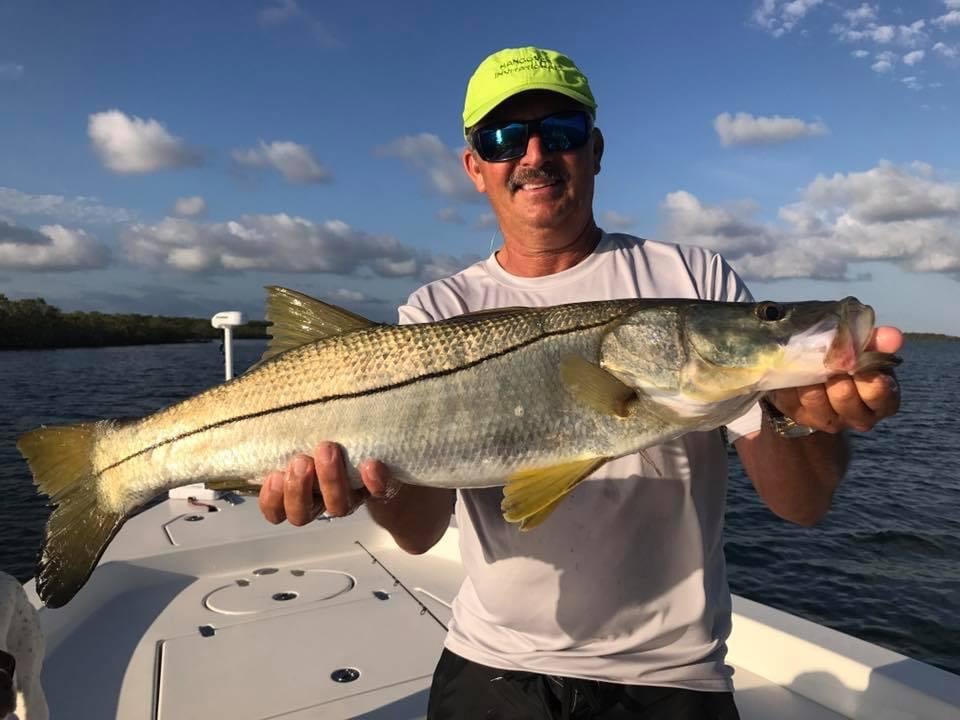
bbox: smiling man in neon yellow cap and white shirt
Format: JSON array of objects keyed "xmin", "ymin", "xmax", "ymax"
[{"xmin": 260, "ymin": 48, "xmax": 901, "ymax": 719}]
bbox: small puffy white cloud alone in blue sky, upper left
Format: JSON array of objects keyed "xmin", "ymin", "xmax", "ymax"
[{"xmin": 87, "ymin": 110, "xmax": 200, "ymax": 174}]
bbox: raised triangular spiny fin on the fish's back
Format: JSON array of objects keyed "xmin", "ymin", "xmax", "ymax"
[{"xmin": 260, "ymin": 286, "xmax": 376, "ymax": 362}]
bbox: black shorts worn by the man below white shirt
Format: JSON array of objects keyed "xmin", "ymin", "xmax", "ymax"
[{"xmin": 427, "ymin": 648, "xmax": 740, "ymax": 720}]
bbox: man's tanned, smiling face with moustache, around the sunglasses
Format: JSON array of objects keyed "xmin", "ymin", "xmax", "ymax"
[{"xmin": 463, "ymin": 91, "xmax": 603, "ymax": 230}]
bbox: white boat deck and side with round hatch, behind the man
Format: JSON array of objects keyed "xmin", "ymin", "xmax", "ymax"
[{"xmin": 28, "ymin": 499, "xmax": 960, "ymax": 720}]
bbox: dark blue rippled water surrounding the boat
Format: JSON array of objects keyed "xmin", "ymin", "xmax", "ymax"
[{"xmin": 0, "ymin": 341, "xmax": 960, "ymax": 673}]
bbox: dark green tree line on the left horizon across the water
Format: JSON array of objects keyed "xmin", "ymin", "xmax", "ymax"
[{"xmin": 0, "ymin": 294, "xmax": 267, "ymax": 350}]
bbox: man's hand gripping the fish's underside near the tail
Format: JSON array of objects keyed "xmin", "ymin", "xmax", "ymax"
[{"xmin": 260, "ymin": 442, "xmax": 391, "ymax": 526}]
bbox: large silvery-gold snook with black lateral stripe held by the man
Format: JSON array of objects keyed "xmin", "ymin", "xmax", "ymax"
[{"xmin": 17, "ymin": 287, "xmax": 899, "ymax": 608}]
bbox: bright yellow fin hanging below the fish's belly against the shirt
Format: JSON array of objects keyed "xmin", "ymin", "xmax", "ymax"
[{"xmin": 500, "ymin": 458, "xmax": 607, "ymax": 530}]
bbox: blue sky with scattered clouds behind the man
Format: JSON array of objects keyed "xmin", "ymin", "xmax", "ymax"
[{"xmin": 0, "ymin": 0, "xmax": 960, "ymax": 335}]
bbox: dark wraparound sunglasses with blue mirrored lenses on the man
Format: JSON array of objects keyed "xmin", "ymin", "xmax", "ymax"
[{"xmin": 470, "ymin": 110, "xmax": 593, "ymax": 162}]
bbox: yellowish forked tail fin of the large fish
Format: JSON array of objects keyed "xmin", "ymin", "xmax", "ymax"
[{"xmin": 17, "ymin": 423, "xmax": 127, "ymax": 608}]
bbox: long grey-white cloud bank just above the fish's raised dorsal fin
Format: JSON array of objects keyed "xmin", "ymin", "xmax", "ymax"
[{"xmin": 121, "ymin": 214, "xmax": 472, "ymax": 279}]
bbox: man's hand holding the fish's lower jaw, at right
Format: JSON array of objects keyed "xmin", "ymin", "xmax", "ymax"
[{"xmin": 769, "ymin": 327, "xmax": 903, "ymax": 433}]
